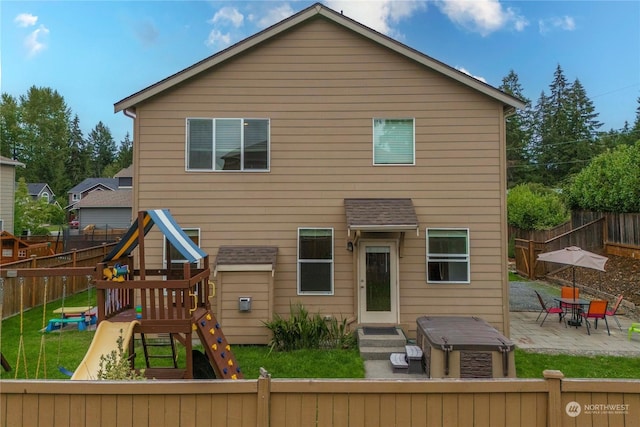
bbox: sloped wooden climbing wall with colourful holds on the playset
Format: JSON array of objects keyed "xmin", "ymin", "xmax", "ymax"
[{"xmin": 193, "ymin": 311, "xmax": 244, "ymax": 380}]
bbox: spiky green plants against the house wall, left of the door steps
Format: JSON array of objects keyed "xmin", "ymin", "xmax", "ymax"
[{"xmin": 263, "ymin": 304, "xmax": 355, "ymax": 351}]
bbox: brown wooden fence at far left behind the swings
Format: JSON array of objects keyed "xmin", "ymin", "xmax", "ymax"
[{"xmin": 0, "ymin": 243, "xmax": 116, "ymax": 318}]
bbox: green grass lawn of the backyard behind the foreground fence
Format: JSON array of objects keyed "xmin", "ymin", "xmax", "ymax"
[{"xmin": 0, "ymin": 292, "xmax": 640, "ymax": 379}]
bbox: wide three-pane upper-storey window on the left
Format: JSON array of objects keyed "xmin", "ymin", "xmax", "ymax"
[{"xmin": 187, "ymin": 119, "xmax": 269, "ymax": 171}]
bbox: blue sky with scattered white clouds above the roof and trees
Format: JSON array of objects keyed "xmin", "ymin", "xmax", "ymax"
[{"xmin": 0, "ymin": 0, "xmax": 640, "ymax": 142}]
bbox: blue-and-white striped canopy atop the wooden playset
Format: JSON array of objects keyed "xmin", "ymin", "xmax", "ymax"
[{"xmin": 102, "ymin": 209, "xmax": 207, "ymax": 263}]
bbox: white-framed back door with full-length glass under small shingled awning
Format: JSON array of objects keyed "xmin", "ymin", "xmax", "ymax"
[{"xmin": 358, "ymin": 240, "xmax": 398, "ymax": 324}]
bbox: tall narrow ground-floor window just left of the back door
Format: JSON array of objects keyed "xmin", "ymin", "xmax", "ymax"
[{"xmin": 298, "ymin": 228, "xmax": 333, "ymax": 295}]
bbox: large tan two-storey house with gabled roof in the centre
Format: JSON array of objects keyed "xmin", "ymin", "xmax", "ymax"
[{"xmin": 115, "ymin": 4, "xmax": 524, "ymax": 344}]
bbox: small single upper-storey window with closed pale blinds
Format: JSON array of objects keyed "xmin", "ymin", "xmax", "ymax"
[{"xmin": 373, "ymin": 119, "xmax": 415, "ymax": 165}]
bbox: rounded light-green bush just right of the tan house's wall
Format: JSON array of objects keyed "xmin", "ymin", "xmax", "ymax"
[{"xmin": 507, "ymin": 184, "xmax": 570, "ymax": 230}]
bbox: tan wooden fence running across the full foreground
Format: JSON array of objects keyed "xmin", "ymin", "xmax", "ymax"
[{"xmin": 0, "ymin": 371, "xmax": 640, "ymax": 427}]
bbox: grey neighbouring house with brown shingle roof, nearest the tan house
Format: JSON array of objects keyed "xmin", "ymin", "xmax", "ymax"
[{"xmin": 75, "ymin": 189, "xmax": 132, "ymax": 229}]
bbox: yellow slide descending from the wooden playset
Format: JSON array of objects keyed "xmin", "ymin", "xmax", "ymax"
[{"xmin": 71, "ymin": 320, "xmax": 138, "ymax": 380}]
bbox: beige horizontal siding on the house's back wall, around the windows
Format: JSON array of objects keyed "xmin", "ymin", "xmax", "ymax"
[{"xmin": 134, "ymin": 19, "xmax": 508, "ymax": 331}]
